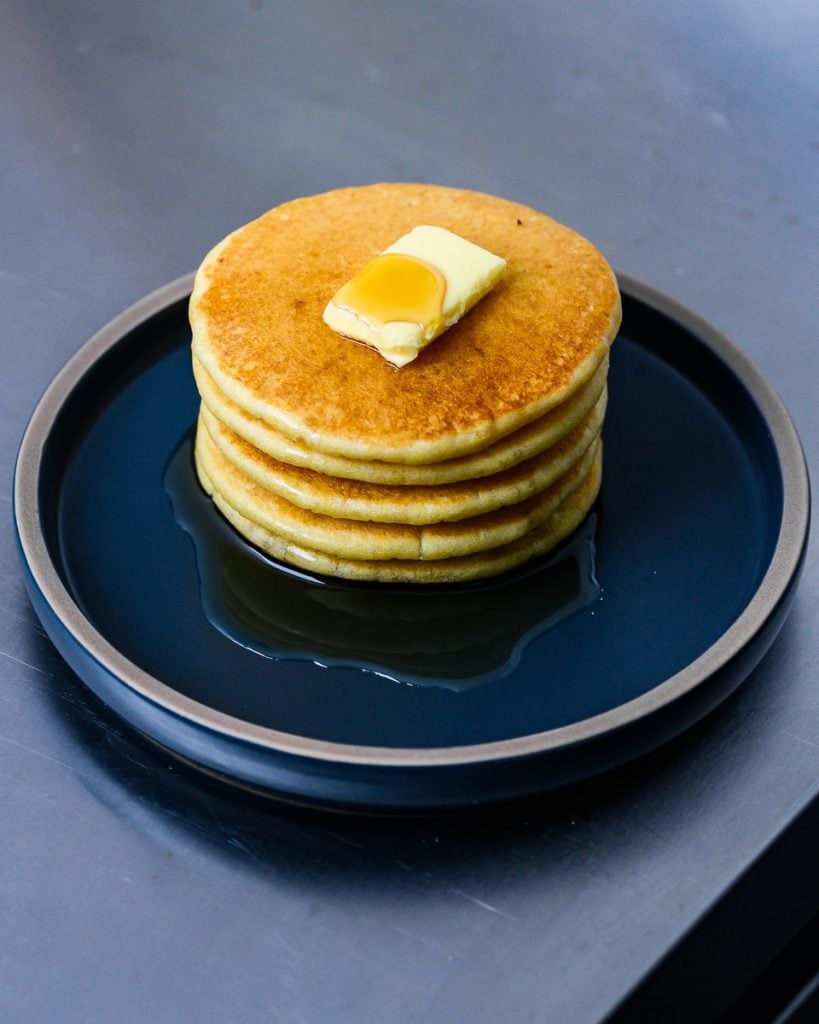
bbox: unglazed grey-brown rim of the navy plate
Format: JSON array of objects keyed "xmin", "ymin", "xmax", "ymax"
[{"xmin": 13, "ymin": 272, "xmax": 811, "ymax": 768}]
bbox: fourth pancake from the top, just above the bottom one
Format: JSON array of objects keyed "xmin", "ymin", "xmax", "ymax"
[{"xmin": 196, "ymin": 423, "xmax": 599, "ymax": 561}]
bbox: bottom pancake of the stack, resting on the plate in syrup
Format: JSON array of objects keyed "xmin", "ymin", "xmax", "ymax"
[{"xmin": 192, "ymin": 442, "xmax": 602, "ymax": 584}]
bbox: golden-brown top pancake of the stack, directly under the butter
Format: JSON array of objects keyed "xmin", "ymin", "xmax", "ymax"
[{"xmin": 190, "ymin": 184, "xmax": 620, "ymax": 465}]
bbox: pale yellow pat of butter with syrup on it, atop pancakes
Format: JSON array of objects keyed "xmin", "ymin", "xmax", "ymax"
[{"xmin": 324, "ymin": 224, "xmax": 506, "ymax": 367}]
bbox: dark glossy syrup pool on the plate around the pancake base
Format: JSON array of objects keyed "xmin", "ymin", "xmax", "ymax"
[{"xmin": 165, "ymin": 432, "xmax": 600, "ymax": 690}]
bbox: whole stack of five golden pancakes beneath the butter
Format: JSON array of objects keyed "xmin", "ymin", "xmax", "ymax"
[{"xmin": 190, "ymin": 184, "xmax": 620, "ymax": 583}]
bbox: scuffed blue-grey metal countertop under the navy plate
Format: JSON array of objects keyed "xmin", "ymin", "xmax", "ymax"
[{"xmin": 0, "ymin": 0, "xmax": 819, "ymax": 1024}]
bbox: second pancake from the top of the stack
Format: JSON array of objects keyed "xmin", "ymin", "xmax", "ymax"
[{"xmin": 193, "ymin": 354, "xmax": 608, "ymax": 486}]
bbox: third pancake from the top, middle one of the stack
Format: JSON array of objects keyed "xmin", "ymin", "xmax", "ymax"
[{"xmin": 202, "ymin": 391, "xmax": 606, "ymax": 525}]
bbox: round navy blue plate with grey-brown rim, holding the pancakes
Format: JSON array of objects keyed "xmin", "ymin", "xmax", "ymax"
[{"xmin": 15, "ymin": 278, "xmax": 809, "ymax": 810}]
